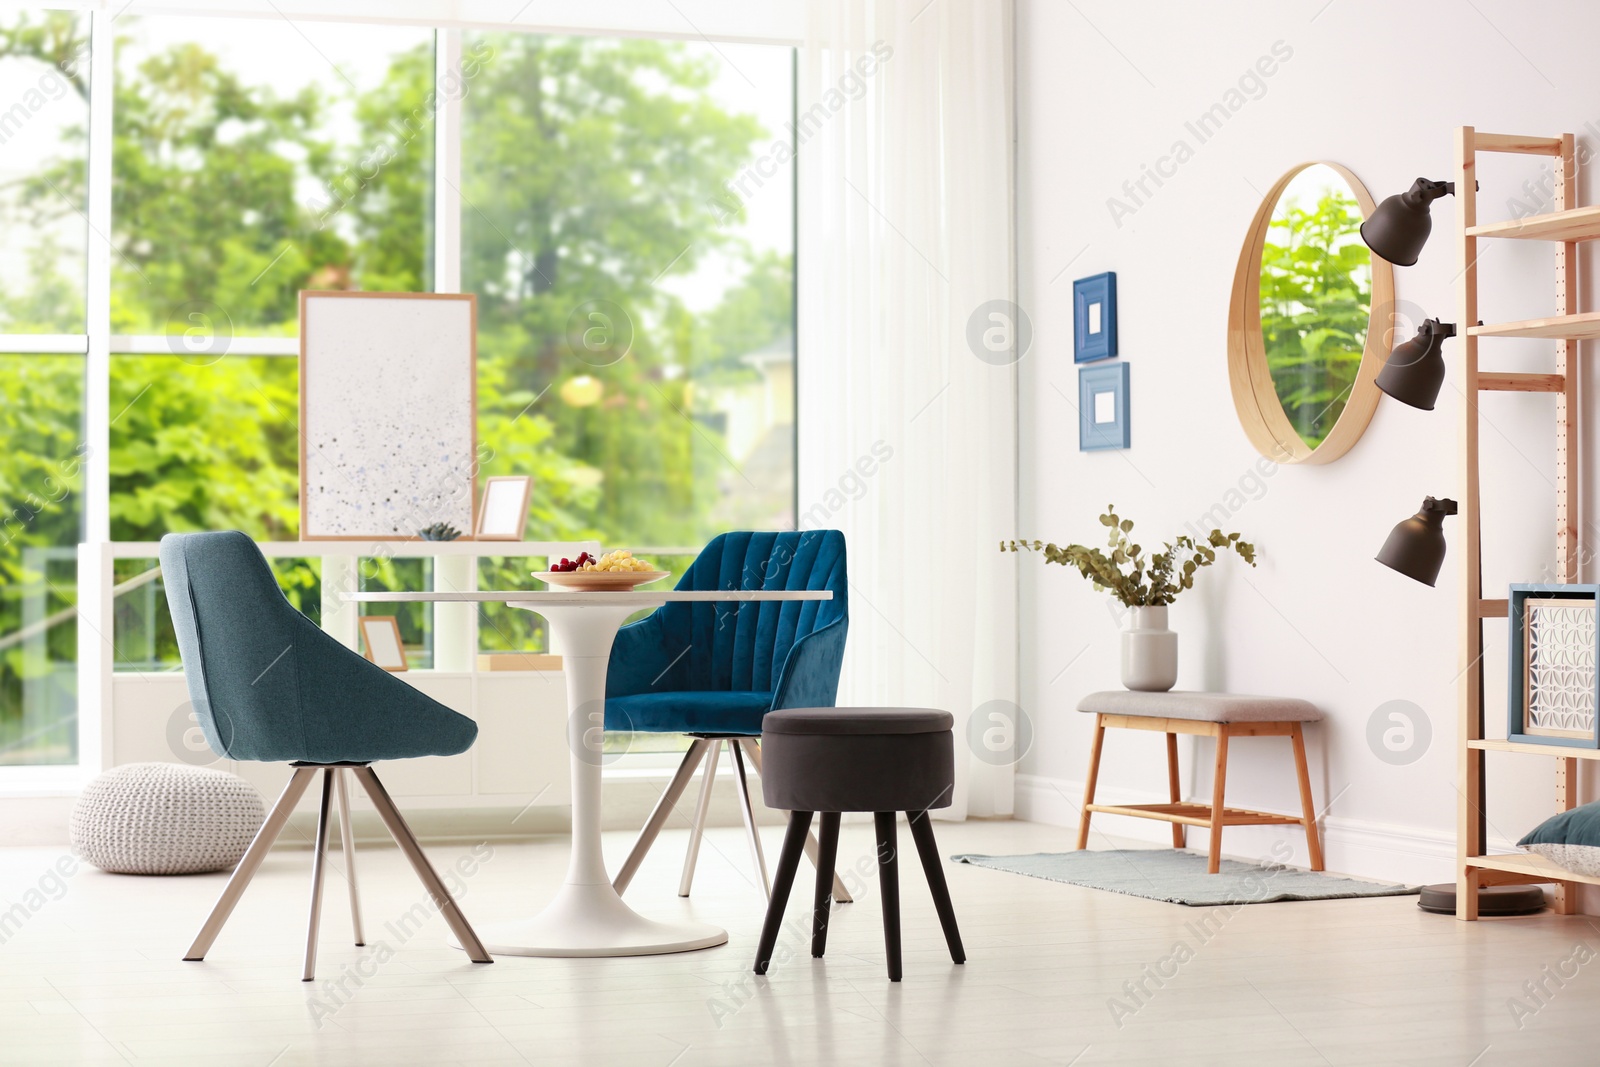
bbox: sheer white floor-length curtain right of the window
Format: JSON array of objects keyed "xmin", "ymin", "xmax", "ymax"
[{"xmin": 795, "ymin": 0, "xmax": 1026, "ymax": 819}]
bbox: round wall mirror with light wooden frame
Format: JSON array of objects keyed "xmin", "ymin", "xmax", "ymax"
[{"xmin": 1227, "ymin": 163, "xmax": 1394, "ymax": 462}]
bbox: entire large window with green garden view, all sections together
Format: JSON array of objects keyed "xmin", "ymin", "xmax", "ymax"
[{"xmin": 0, "ymin": 4, "xmax": 795, "ymax": 763}]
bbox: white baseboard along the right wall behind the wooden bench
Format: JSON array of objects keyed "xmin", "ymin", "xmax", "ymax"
[{"xmin": 1016, "ymin": 774, "xmax": 1514, "ymax": 885}]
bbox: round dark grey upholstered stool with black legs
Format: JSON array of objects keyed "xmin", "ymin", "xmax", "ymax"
[{"xmin": 755, "ymin": 707, "xmax": 966, "ymax": 982}]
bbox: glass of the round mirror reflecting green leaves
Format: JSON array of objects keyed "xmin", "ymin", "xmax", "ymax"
[{"xmin": 1261, "ymin": 187, "xmax": 1373, "ymax": 448}]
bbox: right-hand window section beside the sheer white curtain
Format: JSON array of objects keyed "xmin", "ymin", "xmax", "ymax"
[{"xmin": 459, "ymin": 34, "xmax": 794, "ymax": 648}]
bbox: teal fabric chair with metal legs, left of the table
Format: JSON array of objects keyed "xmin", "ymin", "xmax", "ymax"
[{"xmin": 162, "ymin": 531, "xmax": 493, "ymax": 982}]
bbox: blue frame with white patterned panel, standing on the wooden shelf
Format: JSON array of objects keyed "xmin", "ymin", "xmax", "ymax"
[{"xmin": 1506, "ymin": 582, "xmax": 1600, "ymax": 749}]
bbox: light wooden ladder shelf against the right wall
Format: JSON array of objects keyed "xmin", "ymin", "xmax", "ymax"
[{"xmin": 1456, "ymin": 126, "xmax": 1600, "ymax": 920}]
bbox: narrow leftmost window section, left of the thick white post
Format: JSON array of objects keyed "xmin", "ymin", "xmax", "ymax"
[{"xmin": 0, "ymin": 13, "xmax": 90, "ymax": 765}]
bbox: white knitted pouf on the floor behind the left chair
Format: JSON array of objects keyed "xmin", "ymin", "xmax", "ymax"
[{"xmin": 72, "ymin": 763, "xmax": 267, "ymax": 875}]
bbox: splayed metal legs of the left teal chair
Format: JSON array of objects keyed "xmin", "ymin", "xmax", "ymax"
[{"xmin": 184, "ymin": 765, "xmax": 494, "ymax": 982}]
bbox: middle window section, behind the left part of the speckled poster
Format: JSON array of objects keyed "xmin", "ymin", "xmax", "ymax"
[{"xmin": 110, "ymin": 18, "xmax": 434, "ymax": 541}]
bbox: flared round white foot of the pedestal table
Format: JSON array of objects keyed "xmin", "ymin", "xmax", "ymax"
[{"xmin": 451, "ymin": 883, "xmax": 728, "ymax": 957}]
